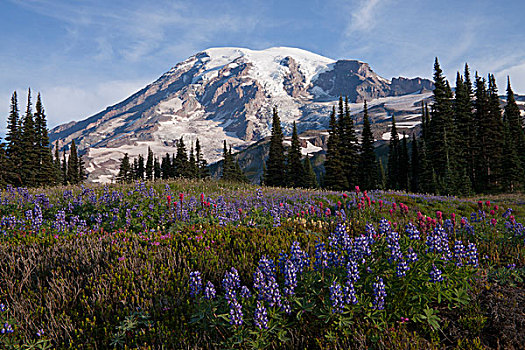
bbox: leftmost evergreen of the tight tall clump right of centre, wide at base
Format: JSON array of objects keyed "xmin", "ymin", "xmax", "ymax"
[{"xmin": 323, "ymin": 104, "xmax": 348, "ymax": 191}]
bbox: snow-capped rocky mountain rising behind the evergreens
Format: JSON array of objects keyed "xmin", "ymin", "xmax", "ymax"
[{"xmin": 50, "ymin": 47, "xmax": 433, "ymax": 182}]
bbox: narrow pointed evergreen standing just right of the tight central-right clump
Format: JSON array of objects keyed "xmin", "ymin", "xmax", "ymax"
[{"xmin": 359, "ymin": 101, "xmax": 378, "ymax": 190}]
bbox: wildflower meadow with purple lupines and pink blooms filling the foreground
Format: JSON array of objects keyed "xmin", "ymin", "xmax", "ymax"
[{"xmin": 0, "ymin": 181, "xmax": 525, "ymax": 349}]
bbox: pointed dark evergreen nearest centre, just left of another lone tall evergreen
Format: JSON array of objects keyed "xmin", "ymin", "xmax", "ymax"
[{"xmin": 264, "ymin": 107, "xmax": 286, "ymax": 186}]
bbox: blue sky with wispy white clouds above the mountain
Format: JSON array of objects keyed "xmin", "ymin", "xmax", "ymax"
[{"xmin": 0, "ymin": 0, "xmax": 525, "ymax": 133}]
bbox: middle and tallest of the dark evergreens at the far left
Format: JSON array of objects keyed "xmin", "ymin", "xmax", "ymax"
[{"xmin": 20, "ymin": 89, "xmax": 39, "ymax": 187}]
